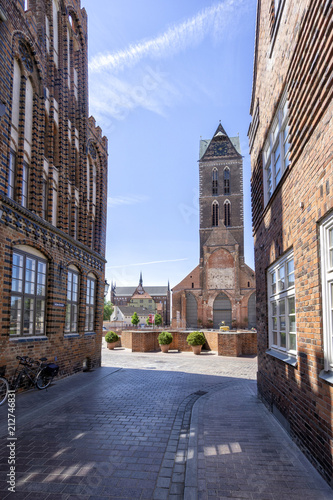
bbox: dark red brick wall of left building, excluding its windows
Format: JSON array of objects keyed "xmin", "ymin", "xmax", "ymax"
[{"xmin": 0, "ymin": 0, "xmax": 107, "ymax": 382}]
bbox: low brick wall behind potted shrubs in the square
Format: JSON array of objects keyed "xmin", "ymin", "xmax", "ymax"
[{"xmin": 112, "ymin": 329, "xmax": 257, "ymax": 357}]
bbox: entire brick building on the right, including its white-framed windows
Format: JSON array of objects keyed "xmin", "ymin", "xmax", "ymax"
[{"xmin": 249, "ymin": 0, "xmax": 333, "ymax": 484}]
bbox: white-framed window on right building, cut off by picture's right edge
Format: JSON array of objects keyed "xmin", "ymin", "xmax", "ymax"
[{"xmin": 320, "ymin": 214, "xmax": 333, "ymax": 371}]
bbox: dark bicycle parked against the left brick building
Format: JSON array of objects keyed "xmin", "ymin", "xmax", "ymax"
[{"xmin": 0, "ymin": 356, "xmax": 59, "ymax": 405}]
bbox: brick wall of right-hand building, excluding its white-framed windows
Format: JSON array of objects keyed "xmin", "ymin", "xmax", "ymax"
[{"xmin": 250, "ymin": 0, "xmax": 333, "ymax": 484}]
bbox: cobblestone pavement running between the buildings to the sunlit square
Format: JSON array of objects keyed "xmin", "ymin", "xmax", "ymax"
[{"xmin": 0, "ymin": 348, "xmax": 333, "ymax": 500}]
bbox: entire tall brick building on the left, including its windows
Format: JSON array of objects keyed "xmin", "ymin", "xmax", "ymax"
[{"xmin": 0, "ymin": 0, "xmax": 107, "ymax": 376}]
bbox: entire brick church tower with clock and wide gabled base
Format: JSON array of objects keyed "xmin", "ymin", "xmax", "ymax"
[{"xmin": 172, "ymin": 124, "xmax": 255, "ymax": 328}]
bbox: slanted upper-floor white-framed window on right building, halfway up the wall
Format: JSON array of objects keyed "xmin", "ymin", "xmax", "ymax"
[{"xmin": 263, "ymin": 92, "xmax": 290, "ymax": 205}]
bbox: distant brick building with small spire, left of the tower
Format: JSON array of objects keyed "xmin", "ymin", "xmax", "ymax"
[{"xmin": 111, "ymin": 273, "xmax": 170, "ymax": 325}]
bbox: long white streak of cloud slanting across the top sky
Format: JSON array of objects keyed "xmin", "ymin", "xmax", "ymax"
[{"xmin": 89, "ymin": 0, "xmax": 246, "ymax": 73}]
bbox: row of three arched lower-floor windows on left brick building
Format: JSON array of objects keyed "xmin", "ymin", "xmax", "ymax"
[{"xmin": 10, "ymin": 250, "xmax": 96, "ymax": 336}]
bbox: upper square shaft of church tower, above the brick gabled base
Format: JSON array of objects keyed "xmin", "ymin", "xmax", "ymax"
[{"xmin": 199, "ymin": 123, "xmax": 244, "ymax": 258}]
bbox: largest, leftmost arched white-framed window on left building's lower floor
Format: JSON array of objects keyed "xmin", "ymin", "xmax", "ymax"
[{"xmin": 9, "ymin": 250, "xmax": 47, "ymax": 335}]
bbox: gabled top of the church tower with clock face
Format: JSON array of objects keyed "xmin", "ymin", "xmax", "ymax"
[{"xmin": 199, "ymin": 123, "xmax": 241, "ymax": 160}]
